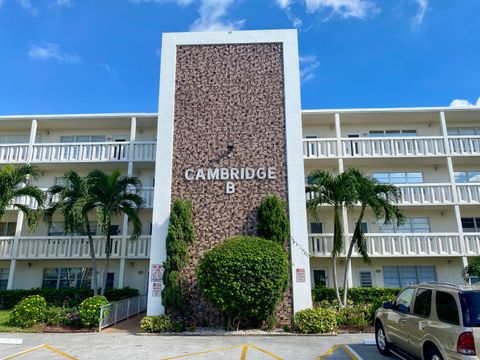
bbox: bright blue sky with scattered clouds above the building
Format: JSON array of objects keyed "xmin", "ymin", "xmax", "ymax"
[{"xmin": 0, "ymin": 0, "xmax": 480, "ymax": 115}]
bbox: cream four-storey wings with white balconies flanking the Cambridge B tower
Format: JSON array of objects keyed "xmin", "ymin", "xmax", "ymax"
[{"xmin": 0, "ymin": 108, "xmax": 480, "ymax": 293}]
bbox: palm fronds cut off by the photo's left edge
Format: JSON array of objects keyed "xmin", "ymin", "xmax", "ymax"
[{"xmin": 0, "ymin": 165, "xmax": 45, "ymax": 231}]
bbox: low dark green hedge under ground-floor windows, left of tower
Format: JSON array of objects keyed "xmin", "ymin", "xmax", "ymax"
[{"xmin": 0, "ymin": 287, "xmax": 138, "ymax": 309}]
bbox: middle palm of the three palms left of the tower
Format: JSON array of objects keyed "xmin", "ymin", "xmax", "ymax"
[{"xmin": 44, "ymin": 170, "xmax": 98, "ymax": 295}]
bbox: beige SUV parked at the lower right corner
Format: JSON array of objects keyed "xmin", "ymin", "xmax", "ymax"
[{"xmin": 375, "ymin": 283, "xmax": 480, "ymax": 360}]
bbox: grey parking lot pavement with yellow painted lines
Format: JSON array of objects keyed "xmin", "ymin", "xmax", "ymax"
[{"xmin": 0, "ymin": 333, "xmax": 400, "ymax": 360}]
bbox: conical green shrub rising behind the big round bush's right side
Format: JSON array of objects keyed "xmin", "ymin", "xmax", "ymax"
[{"xmin": 257, "ymin": 195, "xmax": 290, "ymax": 246}]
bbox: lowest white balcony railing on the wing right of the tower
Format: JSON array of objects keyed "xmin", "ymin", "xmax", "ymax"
[{"xmin": 309, "ymin": 233, "xmax": 464, "ymax": 257}]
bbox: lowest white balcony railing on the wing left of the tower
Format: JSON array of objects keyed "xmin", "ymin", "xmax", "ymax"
[{"xmin": 0, "ymin": 236, "xmax": 150, "ymax": 260}]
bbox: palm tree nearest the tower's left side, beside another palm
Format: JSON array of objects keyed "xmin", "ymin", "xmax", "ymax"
[{"xmin": 84, "ymin": 170, "xmax": 144, "ymax": 295}]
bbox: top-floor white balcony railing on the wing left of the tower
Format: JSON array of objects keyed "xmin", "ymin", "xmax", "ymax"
[{"xmin": 0, "ymin": 141, "xmax": 156, "ymax": 164}]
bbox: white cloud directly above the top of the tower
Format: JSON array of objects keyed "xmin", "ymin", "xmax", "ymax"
[{"xmin": 190, "ymin": 0, "xmax": 245, "ymax": 31}]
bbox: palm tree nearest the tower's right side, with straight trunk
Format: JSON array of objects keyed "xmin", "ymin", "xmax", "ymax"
[{"xmin": 305, "ymin": 170, "xmax": 356, "ymax": 306}]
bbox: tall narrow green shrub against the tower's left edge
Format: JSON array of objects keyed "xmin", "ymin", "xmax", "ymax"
[{"xmin": 162, "ymin": 199, "xmax": 195, "ymax": 315}]
